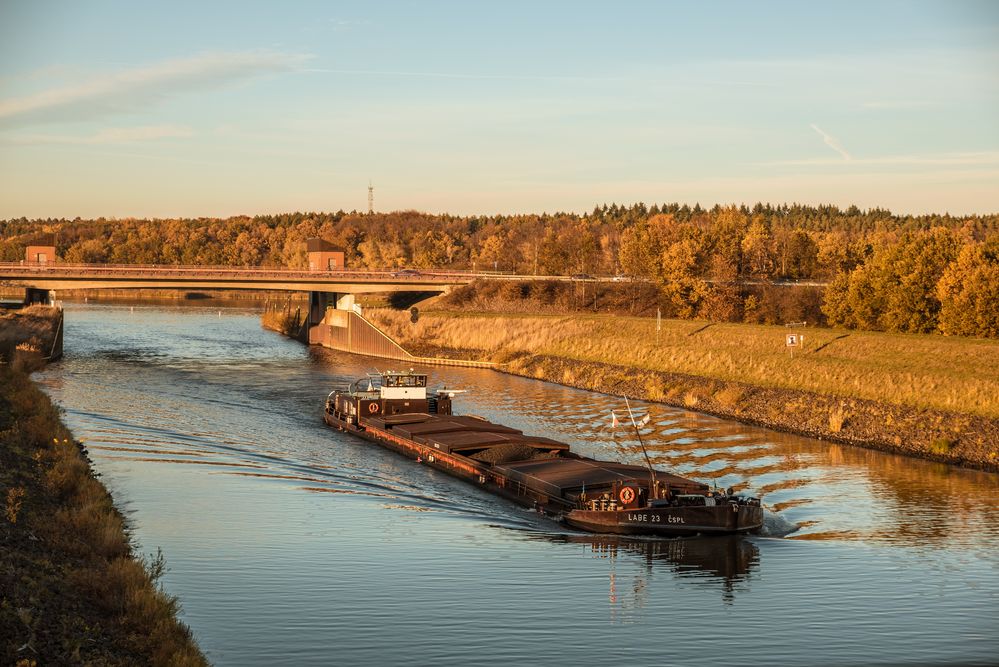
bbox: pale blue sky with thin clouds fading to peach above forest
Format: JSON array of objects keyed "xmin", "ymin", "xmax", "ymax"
[{"xmin": 0, "ymin": 0, "xmax": 999, "ymax": 218}]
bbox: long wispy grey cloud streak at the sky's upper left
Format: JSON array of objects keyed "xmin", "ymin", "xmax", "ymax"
[{"xmin": 0, "ymin": 51, "xmax": 308, "ymax": 126}]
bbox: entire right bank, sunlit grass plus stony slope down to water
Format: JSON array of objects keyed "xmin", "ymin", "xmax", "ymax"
[{"xmin": 366, "ymin": 310, "xmax": 999, "ymax": 470}]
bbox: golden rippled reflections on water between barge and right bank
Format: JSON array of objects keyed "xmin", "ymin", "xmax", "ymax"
[{"xmin": 435, "ymin": 369, "xmax": 999, "ymax": 546}]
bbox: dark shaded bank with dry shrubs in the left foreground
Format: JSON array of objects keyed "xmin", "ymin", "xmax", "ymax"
[{"xmin": 0, "ymin": 313, "xmax": 207, "ymax": 667}]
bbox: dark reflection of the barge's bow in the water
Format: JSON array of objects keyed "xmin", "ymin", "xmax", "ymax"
[{"xmin": 543, "ymin": 534, "xmax": 760, "ymax": 613}]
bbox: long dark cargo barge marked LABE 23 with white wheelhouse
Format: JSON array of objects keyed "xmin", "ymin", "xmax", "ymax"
[{"xmin": 323, "ymin": 371, "xmax": 763, "ymax": 537}]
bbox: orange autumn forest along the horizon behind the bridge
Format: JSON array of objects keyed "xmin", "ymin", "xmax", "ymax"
[{"xmin": 0, "ymin": 203, "xmax": 999, "ymax": 337}]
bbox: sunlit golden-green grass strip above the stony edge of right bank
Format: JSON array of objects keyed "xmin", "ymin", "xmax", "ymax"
[{"xmin": 366, "ymin": 309, "xmax": 999, "ymax": 417}]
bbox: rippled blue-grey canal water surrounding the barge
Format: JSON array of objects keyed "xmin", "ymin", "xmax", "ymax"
[{"xmin": 37, "ymin": 302, "xmax": 999, "ymax": 665}]
